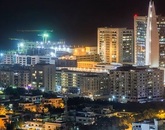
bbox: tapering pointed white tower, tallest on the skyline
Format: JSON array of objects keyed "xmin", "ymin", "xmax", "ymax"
[{"xmin": 145, "ymin": 1, "xmax": 159, "ymax": 67}]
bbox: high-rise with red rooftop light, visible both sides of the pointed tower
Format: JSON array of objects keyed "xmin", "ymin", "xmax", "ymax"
[{"xmin": 134, "ymin": 12, "xmax": 165, "ymax": 67}]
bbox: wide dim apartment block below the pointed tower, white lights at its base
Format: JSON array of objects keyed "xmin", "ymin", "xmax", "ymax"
[{"xmin": 109, "ymin": 66, "xmax": 164, "ymax": 103}]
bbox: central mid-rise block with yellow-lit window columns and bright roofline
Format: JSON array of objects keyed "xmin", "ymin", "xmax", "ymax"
[{"xmin": 56, "ymin": 68, "xmax": 108, "ymax": 95}]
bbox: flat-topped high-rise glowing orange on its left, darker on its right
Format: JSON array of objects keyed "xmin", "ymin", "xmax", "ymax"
[{"xmin": 97, "ymin": 27, "xmax": 133, "ymax": 63}]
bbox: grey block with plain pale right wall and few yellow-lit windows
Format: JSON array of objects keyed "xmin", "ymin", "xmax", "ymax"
[{"xmin": 31, "ymin": 64, "xmax": 56, "ymax": 91}]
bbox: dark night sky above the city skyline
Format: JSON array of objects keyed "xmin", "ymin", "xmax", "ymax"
[{"xmin": 0, "ymin": 0, "xmax": 165, "ymax": 50}]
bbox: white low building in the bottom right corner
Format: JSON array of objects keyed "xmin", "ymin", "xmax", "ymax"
[{"xmin": 132, "ymin": 119, "xmax": 165, "ymax": 130}]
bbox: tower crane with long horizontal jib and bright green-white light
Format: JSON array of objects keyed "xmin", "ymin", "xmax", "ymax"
[{"xmin": 17, "ymin": 30, "xmax": 53, "ymax": 43}]
